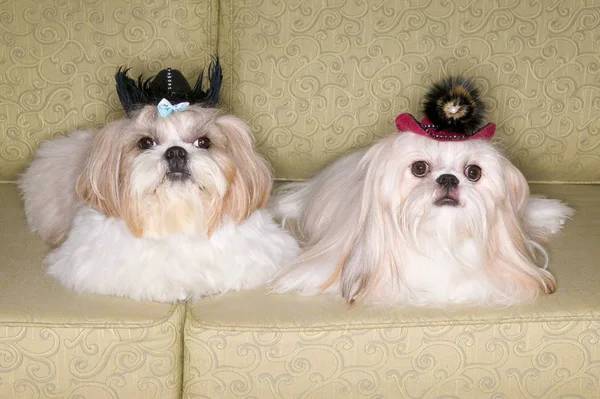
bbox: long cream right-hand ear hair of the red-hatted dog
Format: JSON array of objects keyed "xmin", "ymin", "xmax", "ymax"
[{"xmin": 485, "ymin": 159, "xmax": 556, "ymax": 305}]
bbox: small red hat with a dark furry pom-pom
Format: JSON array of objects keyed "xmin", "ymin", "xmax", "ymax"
[{"xmin": 396, "ymin": 76, "xmax": 496, "ymax": 141}]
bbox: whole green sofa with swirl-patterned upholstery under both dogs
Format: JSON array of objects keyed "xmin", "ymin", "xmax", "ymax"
[{"xmin": 0, "ymin": 0, "xmax": 600, "ymax": 399}]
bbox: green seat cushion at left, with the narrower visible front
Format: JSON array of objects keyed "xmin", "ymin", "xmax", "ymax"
[{"xmin": 0, "ymin": 184, "xmax": 184, "ymax": 399}]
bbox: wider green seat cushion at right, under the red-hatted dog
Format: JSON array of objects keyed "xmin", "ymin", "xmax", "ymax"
[{"xmin": 183, "ymin": 185, "xmax": 600, "ymax": 399}]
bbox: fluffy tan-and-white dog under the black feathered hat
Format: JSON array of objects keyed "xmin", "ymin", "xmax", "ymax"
[{"xmin": 20, "ymin": 101, "xmax": 298, "ymax": 302}]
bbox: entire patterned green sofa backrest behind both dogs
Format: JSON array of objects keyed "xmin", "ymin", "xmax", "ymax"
[{"xmin": 0, "ymin": 0, "xmax": 600, "ymax": 183}]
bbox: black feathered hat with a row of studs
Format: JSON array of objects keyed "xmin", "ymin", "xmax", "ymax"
[{"xmin": 115, "ymin": 57, "xmax": 223, "ymax": 117}]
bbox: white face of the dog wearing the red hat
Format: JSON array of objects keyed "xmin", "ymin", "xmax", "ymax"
[{"xmin": 381, "ymin": 134, "xmax": 528, "ymax": 244}]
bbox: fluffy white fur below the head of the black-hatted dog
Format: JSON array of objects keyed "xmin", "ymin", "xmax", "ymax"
[{"xmin": 46, "ymin": 206, "xmax": 297, "ymax": 302}]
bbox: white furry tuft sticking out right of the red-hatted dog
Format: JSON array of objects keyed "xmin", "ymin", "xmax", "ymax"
[{"xmin": 525, "ymin": 197, "xmax": 575, "ymax": 238}]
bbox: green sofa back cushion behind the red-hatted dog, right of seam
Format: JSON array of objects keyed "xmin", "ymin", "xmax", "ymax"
[{"xmin": 219, "ymin": 0, "xmax": 600, "ymax": 182}]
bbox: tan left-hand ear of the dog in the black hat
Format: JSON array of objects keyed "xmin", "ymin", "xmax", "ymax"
[{"xmin": 76, "ymin": 121, "xmax": 125, "ymax": 220}]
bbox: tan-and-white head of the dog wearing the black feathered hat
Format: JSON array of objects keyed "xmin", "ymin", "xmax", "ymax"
[{"xmin": 78, "ymin": 106, "xmax": 271, "ymax": 238}]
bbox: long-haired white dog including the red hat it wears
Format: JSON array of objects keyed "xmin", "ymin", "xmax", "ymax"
[{"xmin": 272, "ymin": 76, "xmax": 573, "ymax": 306}]
